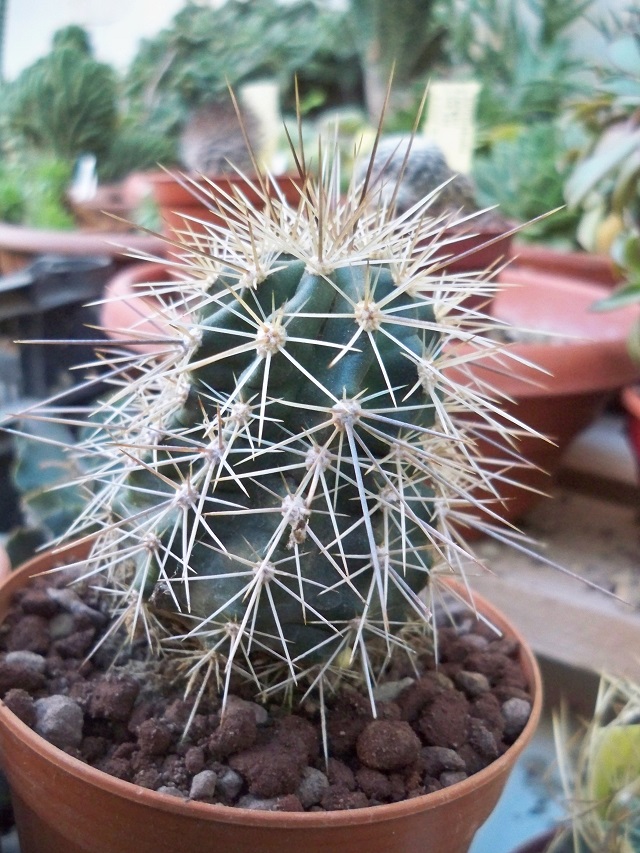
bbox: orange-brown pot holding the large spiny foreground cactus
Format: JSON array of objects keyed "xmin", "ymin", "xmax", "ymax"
[{"xmin": 0, "ymin": 548, "xmax": 542, "ymax": 853}]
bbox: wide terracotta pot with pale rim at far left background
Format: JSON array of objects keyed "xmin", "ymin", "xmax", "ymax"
[{"xmin": 0, "ymin": 222, "xmax": 164, "ymax": 275}]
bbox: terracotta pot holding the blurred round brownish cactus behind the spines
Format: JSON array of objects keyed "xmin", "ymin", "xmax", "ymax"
[{"xmin": 146, "ymin": 172, "xmax": 303, "ymax": 238}]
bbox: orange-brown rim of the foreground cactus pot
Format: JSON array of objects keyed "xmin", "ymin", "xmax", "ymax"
[{"xmin": 0, "ymin": 540, "xmax": 543, "ymax": 829}]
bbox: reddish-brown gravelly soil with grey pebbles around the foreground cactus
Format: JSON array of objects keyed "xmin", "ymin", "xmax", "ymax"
[{"xmin": 0, "ymin": 575, "xmax": 531, "ymax": 811}]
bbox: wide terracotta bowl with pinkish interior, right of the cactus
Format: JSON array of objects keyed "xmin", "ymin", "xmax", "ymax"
[{"xmin": 452, "ymin": 266, "xmax": 640, "ymax": 521}]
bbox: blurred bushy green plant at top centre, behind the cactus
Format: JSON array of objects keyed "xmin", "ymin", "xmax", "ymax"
[{"xmin": 126, "ymin": 0, "xmax": 361, "ymax": 138}]
